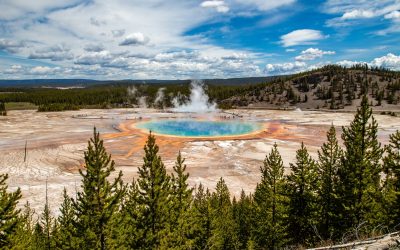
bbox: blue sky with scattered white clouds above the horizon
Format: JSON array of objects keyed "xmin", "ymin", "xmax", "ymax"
[{"xmin": 0, "ymin": 0, "xmax": 400, "ymax": 79}]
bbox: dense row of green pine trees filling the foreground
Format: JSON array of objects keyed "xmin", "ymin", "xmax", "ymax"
[{"xmin": 0, "ymin": 96, "xmax": 400, "ymax": 250}]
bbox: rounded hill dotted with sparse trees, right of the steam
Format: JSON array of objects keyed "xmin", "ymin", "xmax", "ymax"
[{"xmin": 222, "ymin": 65, "xmax": 400, "ymax": 110}]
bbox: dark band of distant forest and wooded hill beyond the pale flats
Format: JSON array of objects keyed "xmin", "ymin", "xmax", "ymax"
[{"xmin": 0, "ymin": 65, "xmax": 400, "ymax": 110}]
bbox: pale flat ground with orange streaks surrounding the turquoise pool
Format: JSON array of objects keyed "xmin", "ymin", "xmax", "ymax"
[{"xmin": 0, "ymin": 109, "xmax": 400, "ymax": 214}]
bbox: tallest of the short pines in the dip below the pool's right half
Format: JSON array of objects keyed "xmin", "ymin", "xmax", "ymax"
[{"xmin": 208, "ymin": 178, "xmax": 240, "ymax": 249}]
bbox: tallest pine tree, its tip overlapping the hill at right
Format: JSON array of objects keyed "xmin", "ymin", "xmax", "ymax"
[{"xmin": 339, "ymin": 95, "xmax": 383, "ymax": 229}]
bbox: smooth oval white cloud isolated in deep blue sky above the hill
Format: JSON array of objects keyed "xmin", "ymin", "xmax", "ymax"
[{"xmin": 281, "ymin": 29, "xmax": 326, "ymax": 47}]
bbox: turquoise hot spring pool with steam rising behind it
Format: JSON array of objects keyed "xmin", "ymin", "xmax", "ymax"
[{"xmin": 137, "ymin": 120, "xmax": 261, "ymax": 137}]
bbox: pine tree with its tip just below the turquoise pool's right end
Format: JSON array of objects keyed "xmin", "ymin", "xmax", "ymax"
[{"xmin": 254, "ymin": 143, "xmax": 287, "ymax": 249}]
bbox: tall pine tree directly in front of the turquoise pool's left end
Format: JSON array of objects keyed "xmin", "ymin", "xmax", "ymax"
[{"xmin": 137, "ymin": 133, "xmax": 171, "ymax": 249}]
